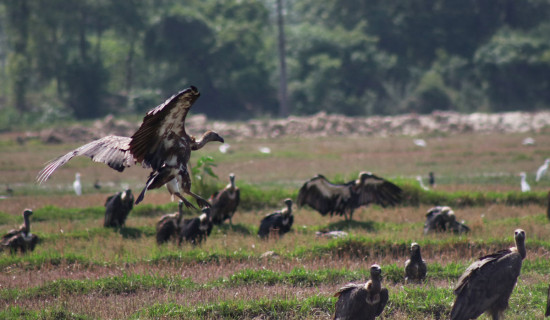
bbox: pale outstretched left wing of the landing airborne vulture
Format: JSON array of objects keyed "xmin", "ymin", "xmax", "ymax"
[{"xmin": 37, "ymin": 136, "xmax": 136, "ymax": 183}]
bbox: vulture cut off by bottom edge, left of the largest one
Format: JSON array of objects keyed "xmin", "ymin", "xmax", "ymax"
[{"xmin": 334, "ymin": 264, "xmax": 389, "ymax": 320}]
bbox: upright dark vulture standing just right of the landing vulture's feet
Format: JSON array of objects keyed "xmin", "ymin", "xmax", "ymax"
[{"xmin": 210, "ymin": 173, "xmax": 241, "ymax": 224}]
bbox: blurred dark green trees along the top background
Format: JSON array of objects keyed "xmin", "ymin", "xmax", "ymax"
[{"xmin": 0, "ymin": 0, "xmax": 550, "ymax": 127}]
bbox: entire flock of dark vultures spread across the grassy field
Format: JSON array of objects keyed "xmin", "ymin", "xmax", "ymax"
[{"xmin": 0, "ymin": 86, "xmax": 544, "ymax": 320}]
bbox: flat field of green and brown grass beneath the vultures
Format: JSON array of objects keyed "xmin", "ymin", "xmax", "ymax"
[{"xmin": 0, "ymin": 134, "xmax": 550, "ymax": 319}]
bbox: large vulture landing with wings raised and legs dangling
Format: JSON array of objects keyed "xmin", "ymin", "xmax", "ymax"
[{"xmin": 37, "ymin": 86, "xmax": 224, "ymax": 208}]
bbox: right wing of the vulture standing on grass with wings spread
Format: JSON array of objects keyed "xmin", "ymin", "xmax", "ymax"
[{"xmin": 357, "ymin": 173, "xmax": 403, "ymax": 207}]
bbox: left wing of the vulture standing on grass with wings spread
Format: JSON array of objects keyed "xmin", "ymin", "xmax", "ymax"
[{"xmin": 297, "ymin": 175, "xmax": 351, "ymax": 215}]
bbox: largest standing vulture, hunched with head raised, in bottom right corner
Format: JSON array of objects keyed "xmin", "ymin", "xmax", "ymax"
[{"xmin": 451, "ymin": 229, "xmax": 526, "ymax": 320}]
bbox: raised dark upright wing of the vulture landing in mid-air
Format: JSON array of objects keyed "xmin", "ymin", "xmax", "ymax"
[{"xmin": 130, "ymin": 86, "xmax": 200, "ymax": 170}]
